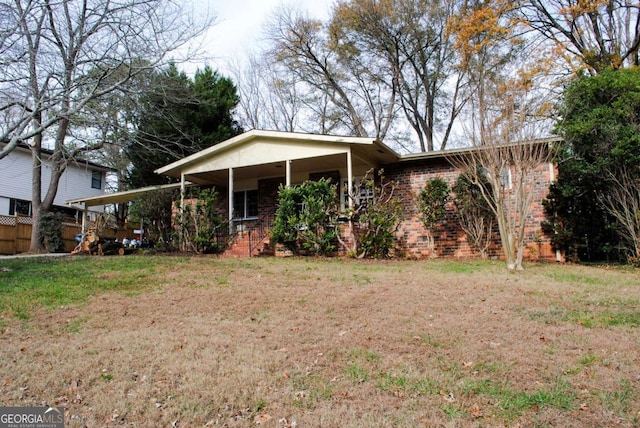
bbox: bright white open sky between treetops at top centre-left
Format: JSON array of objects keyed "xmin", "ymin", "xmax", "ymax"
[{"xmin": 186, "ymin": 0, "xmax": 334, "ymax": 75}]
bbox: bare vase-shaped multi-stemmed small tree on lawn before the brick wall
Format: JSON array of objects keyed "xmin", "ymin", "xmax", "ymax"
[{"xmin": 449, "ymin": 92, "xmax": 550, "ymax": 270}]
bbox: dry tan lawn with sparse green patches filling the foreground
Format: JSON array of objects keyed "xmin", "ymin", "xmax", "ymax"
[{"xmin": 0, "ymin": 258, "xmax": 640, "ymax": 427}]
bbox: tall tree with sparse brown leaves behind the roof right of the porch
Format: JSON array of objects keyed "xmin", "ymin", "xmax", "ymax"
[{"xmin": 330, "ymin": 0, "xmax": 464, "ymax": 152}]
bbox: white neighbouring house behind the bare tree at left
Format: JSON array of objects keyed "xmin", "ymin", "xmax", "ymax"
[{"xmin": 0, "ymin": 147, "xmax": 111, "ymax": 221}]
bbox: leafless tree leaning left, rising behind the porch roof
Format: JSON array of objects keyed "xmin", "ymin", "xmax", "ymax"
[{"xmin": 267, "ymin": 7, "xmax": 395, "ymax": 139}]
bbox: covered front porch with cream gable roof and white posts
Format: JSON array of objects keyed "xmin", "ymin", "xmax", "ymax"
[{"xmin": 156, "ymin": 130, "xmax": 399, "ymax": 254}]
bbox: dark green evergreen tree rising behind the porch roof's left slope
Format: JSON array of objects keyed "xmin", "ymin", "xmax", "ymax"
[{"xmin": 127, "ymin": 65, "xmax": 242, "ymax": 187}]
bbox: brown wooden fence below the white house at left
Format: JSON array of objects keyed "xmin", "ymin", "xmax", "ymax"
[{"xmin": 0, "ymin": 215, "xmax": 133, "ymax": 254}]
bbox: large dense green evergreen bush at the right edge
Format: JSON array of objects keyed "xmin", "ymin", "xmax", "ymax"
[{"xmin": 543, "ymin": 69, "xmax": 640, "ymax": 261}]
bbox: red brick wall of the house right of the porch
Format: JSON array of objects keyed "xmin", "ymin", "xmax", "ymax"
[{"xmin": 384, "ymin": 158, "xmax": 555, "ymax": 260}]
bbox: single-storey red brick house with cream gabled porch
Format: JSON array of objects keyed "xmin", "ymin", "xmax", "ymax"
[{"xmin": 151, "ymin": 130, "xmax": 560, "ymax": 261}]
